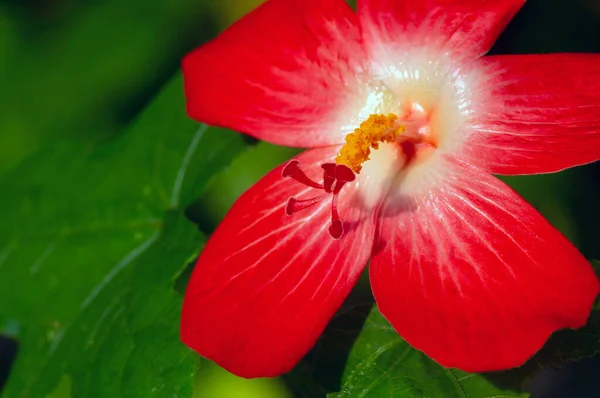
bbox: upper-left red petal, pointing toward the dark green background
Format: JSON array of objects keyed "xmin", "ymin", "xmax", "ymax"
[{"xmin": 183, "ymin": 0, "xmax": 365, "ymax": 147}]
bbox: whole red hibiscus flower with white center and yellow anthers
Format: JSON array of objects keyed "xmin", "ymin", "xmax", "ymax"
[{"xmin": 181, "ymin": 0, "xmax": 600, "ymax": 377}]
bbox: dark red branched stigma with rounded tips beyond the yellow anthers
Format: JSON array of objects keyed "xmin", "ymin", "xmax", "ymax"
[{"xmin": 281, "ymin": 159, "xmax": 356, "ymax": 239}]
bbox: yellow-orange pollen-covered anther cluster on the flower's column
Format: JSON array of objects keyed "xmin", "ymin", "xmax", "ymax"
[{"xmin": 335, "ymin": 113, "xmax": 405, "ymax": 174}]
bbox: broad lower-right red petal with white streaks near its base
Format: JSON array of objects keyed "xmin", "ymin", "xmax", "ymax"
[{"xmin": 370, "ymin": 156, "xmax": 599, "ymax": 372}]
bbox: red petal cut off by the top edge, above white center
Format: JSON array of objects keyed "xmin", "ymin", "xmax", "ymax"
[{"xmin": 358, "ymin": 0, "xmax": 525, "ymax": 61}]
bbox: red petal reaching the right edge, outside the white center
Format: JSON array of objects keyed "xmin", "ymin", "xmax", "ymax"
[{"xmin": 466, "ymin": 54, "xmax": 600, "ymax": 174}]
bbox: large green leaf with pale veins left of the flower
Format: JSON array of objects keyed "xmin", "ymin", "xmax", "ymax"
[{"xmin": 0, "ymin": 73, "xmax": 246, "ymax": 397}]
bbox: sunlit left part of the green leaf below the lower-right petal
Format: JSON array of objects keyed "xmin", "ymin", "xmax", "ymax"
[{"xmin": 328, "ymin": 307, "xmax": 527, "ymax": 398}]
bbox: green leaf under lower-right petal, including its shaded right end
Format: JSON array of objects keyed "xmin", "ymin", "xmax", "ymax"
[{"xmin": 328, "ymin": 300, "xmax": 600, "ymax": 398}]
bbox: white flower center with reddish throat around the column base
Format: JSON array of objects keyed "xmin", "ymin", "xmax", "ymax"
[{"xmin": 350, "ymin": 54, "xmax": 481, "ymax": 210}]
